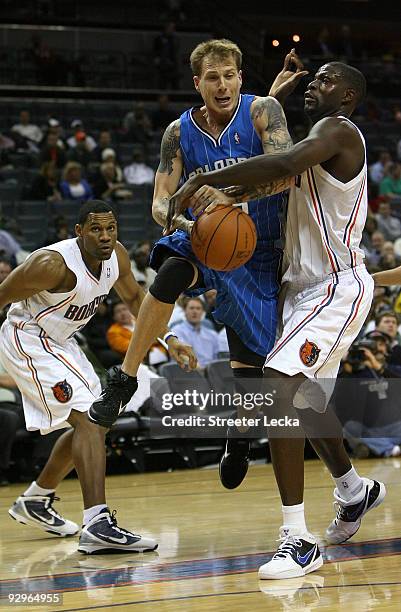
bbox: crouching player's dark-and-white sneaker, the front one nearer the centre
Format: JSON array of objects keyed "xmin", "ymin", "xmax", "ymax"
[{"xmin": 78, "ymin": 507, "xmax": 158, "ymax": 555}]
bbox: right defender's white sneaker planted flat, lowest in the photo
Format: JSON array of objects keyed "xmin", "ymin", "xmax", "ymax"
[{"xmin": 259, "ymin": 525, "xmax": 323, "ymax": 580}]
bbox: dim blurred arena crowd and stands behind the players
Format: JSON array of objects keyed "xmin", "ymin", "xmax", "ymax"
[{"xmin": 0, "ymin": 0, "xmax": 401, "ymax": 483}]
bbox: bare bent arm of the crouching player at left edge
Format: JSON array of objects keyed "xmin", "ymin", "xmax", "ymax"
[{"xmin": 0, "ymin": 250, "xmax": 68, "ymax": 309}]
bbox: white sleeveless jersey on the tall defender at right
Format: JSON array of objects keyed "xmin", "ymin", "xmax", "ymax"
[{"xmin": 283, "ymin": 117, "xmax": 368, "ymax": 285}]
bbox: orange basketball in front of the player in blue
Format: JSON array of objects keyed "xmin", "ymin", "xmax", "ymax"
[{"xmin": 191, "ymin": 204, "xmax": 256, "ymax": 271}]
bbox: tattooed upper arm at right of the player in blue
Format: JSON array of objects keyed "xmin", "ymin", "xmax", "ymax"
[{"xmin": 252, "ymin": 97, "xmax": 292, "ymax": 154}]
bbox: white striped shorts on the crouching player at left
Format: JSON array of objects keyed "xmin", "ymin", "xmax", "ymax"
[{"xmin": 0, "ymin": 321, "xmax": 101, "ymax": 434}]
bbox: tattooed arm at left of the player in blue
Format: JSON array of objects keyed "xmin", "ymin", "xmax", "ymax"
[{"xmin": 152, "ymin": 119, "xmax": 192, "ymax": 233}]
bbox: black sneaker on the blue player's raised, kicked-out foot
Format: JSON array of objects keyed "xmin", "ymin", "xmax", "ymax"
[{"xmin": 88, "ymin": 366, "xmax": 138, "ymax": 429}]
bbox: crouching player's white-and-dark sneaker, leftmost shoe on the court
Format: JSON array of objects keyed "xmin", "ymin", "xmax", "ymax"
[{"xmin": 8, "ymin": 493, "xmax": 79, "ymax": 536}]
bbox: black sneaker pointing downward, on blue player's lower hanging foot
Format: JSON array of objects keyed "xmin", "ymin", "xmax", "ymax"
[{"xmin": 219, "ymin": 424, "xmax": 251, "ymax": 489}]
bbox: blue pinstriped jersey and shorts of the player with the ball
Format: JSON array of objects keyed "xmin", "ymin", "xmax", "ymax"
[{"xmin": 150, "ymin": 94, "xmax": 287, "ymax": 356}]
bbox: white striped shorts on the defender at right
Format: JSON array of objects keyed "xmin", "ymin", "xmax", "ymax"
[{"xmin": 265, "ymin": 265, "xmax": 374, "ymax": 379}]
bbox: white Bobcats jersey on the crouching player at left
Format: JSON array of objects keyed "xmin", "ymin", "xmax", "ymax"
[{"xmin": 7, "ymin": 238, "xmax": 119, "ymax": 344}]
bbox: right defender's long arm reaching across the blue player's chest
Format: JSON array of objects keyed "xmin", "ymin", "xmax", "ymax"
[{"xmin": 168, "ymin": 117, "xmax": 346, "ymax": 225}]
